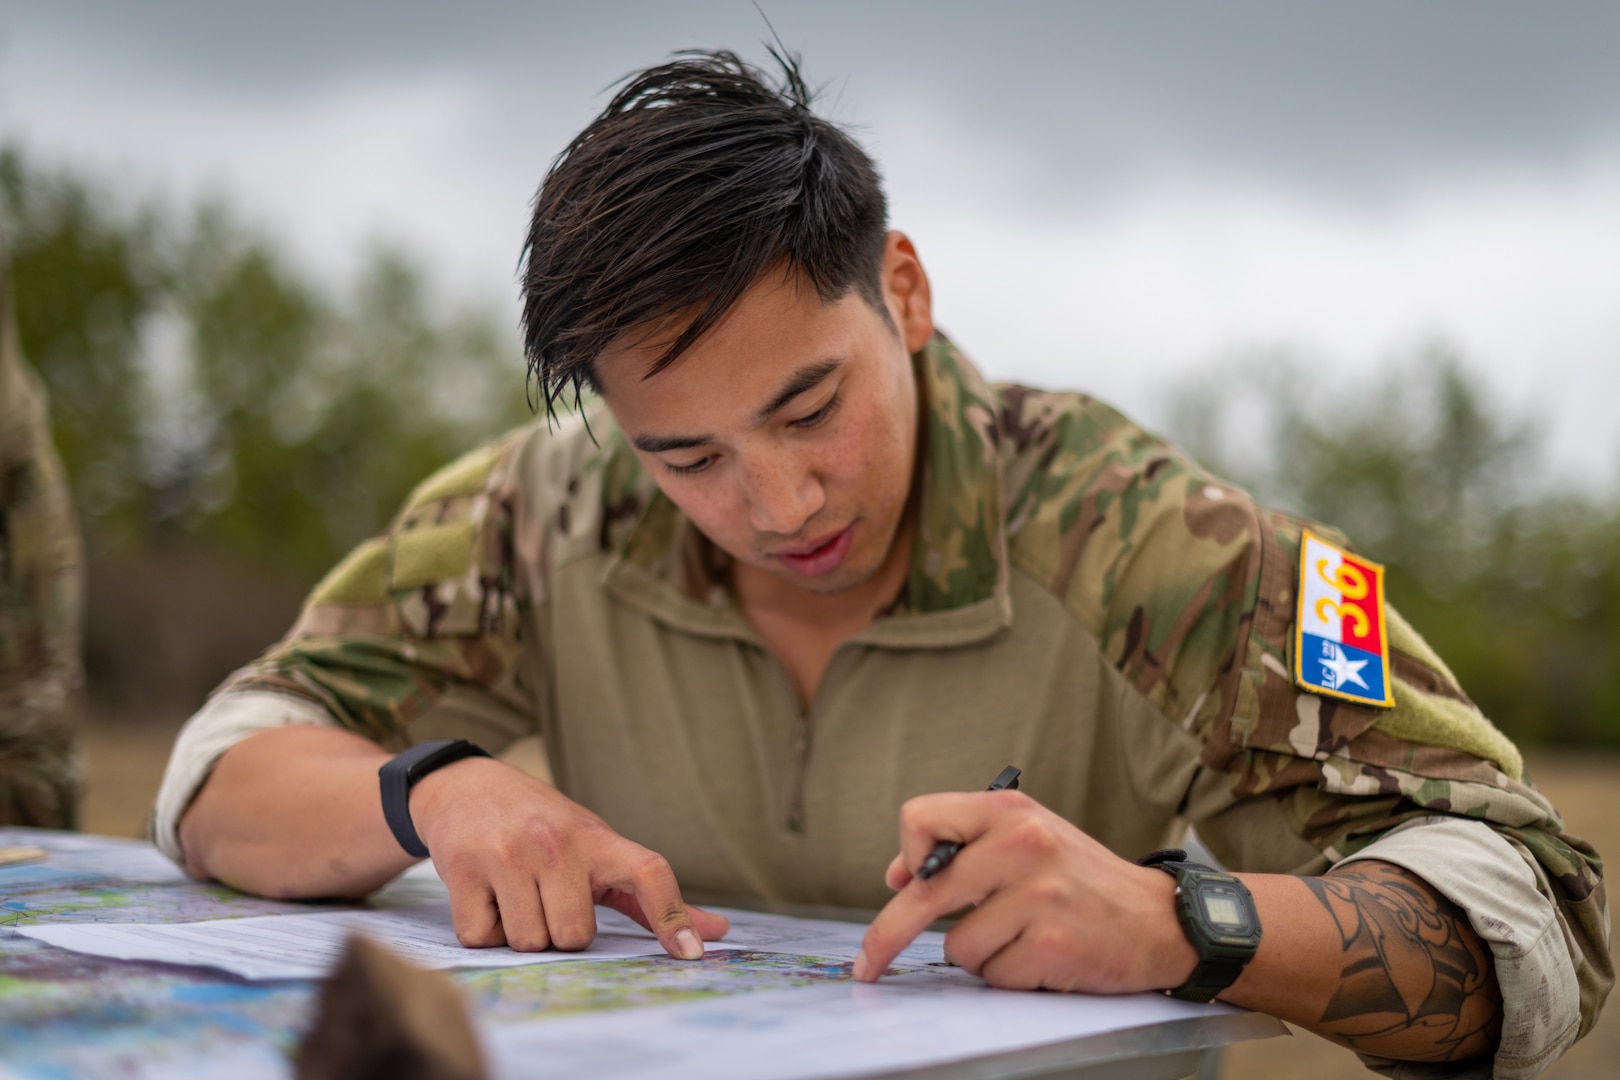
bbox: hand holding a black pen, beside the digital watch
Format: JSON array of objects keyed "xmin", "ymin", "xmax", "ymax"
[{"xmin": 854, "ymin": 792, "xmax": 1197, "ymax": 994}]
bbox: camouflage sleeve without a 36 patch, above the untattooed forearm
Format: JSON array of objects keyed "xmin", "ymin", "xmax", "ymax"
[{"xmin": 212, "ymin": 431, "xmax": 539, "ymax": 753}]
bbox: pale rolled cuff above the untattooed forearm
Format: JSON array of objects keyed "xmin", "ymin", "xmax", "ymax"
[{"xmin": 152, "ymin": 690, "xmax": 337, "ymax": 868}]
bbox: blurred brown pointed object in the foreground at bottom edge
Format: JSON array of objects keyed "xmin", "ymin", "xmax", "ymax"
[{"xmin": 295, "ymin": 934, "xmax": 488, "ymax": 1080}]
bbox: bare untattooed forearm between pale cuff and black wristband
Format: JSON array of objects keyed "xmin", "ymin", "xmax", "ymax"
[{"xmin": 180, "ymin": 724, "xmax": 413, "ymax": 899}]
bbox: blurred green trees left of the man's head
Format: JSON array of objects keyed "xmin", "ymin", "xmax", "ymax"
[{"xmin": 0, "ymin": 149, "xmax": 530, "ymax": 576}]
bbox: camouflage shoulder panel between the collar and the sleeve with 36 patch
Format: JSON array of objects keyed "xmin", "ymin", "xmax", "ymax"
[{"xmin": 996, "ymin": 385, "xmax": 1260, "ymax": 729}]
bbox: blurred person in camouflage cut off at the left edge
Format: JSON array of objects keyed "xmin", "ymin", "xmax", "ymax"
[{"xmin": 0, "ymin": 236, "xmax": 84, "ymax": 829}]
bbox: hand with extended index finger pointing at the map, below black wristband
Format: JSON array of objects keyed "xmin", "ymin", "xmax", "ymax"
[{"xmin": 410, "ymin": 758, "xmax": 729, "ymax": 960}]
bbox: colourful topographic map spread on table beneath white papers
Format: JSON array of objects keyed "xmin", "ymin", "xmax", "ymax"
[{"xmin": 0, "ymin": 829, "xmax": 907, "ymax": 1078}]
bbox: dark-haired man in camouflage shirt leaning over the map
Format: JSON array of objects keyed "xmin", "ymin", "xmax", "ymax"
[{"xmin": 156, "ymin": 48, "xmax": 1612, "ymax": 1075}]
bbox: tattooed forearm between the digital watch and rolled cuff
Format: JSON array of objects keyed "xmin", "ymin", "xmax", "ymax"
[{"xmin": 1221, "ymin": 860, "xmax": 1502, "ymax": 1061}]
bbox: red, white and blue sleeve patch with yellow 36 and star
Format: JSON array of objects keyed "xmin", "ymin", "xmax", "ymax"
[{"xmin": 1294, "ymin": 529, "xmax": 1395, "ymax": 708}]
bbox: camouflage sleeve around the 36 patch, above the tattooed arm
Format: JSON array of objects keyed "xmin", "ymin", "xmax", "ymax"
[{"xmin": 1199, "ymin": 512, "xmax": 1614, "ymax": 1067}]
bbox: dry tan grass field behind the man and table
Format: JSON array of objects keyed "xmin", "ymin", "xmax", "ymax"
[{"xmin": 81, "ymin": 721, "xmax": 1620, "ymax": 1080}]
